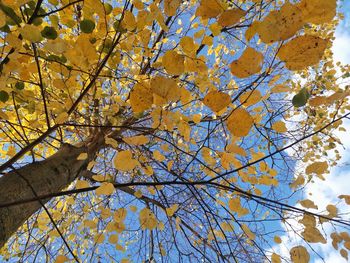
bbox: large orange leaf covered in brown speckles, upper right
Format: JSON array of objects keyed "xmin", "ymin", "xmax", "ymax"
[{"xmin": 277, "ymin": 35, "xmax": 329, "ymax": 70}]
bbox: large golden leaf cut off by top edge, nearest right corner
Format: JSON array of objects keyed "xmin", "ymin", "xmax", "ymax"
[{"xmin": 299, "ymin": 0, "xmax": 337, "ymax": 24}]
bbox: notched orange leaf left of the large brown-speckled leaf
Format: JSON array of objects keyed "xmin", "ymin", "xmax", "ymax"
[{"xmin": 231, "ymin": 47, "xmax": 264, "ymax": 78}]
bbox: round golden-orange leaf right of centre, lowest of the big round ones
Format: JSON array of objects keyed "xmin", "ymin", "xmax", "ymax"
[{"xmin": 226, "ymin": 108, "xmax": 254, "ymax": 137}]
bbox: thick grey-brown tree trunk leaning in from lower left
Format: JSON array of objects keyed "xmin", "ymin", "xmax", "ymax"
[{"xmin": 0, "ymin": 136, "xmax": 103, "ymax": 248}]
